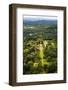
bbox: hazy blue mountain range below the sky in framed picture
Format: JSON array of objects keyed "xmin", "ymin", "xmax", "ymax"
[{"xmin": 23, "ymin": 20, "xmax": 57, "ymax": 25}]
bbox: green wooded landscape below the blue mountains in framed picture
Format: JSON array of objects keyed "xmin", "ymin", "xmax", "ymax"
[{"xmin": 23, "ymin": 18, "xmax": 57, "ymax": 74}]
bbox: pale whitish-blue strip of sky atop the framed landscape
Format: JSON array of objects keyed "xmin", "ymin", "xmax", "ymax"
[{"xmin": 23, "ymin": 16, "xmax": 57, "ymax": 21}]
